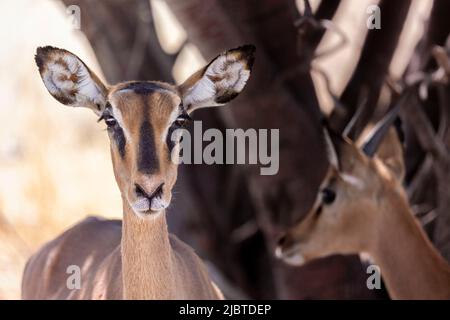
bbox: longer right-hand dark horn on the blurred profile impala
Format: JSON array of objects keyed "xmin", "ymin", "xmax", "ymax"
[{"xmin": 362, "ymin": 98, "xmax": 404, "ymax": 157}]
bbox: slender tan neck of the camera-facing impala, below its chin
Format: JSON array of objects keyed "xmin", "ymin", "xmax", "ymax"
[{"xmin": 121, "ymin": 200, "xmax": 175, "ymax": 300}]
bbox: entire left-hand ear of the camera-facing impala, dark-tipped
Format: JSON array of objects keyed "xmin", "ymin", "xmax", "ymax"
[{"xmin": 35, "ymin": 46, "xmax": 107, "ymax": 115}]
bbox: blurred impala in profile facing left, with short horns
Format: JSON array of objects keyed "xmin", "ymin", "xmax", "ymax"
[{"xmin": 276, "ymin": 107, "xmax": 450, "ymax": 299}]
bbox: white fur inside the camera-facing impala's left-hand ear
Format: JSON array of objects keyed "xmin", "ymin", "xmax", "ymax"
[{"xmin": 43, "ymin": 54, "xmax": 105, "ymax": 107}]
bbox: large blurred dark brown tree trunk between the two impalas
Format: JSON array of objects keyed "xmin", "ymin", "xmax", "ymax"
[{"xmin": 167, "ymin": 0, "xmax": 380, "ymax": 298}]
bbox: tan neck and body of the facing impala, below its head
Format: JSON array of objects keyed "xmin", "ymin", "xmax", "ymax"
[{"xmin": 22, "ymin": 214, "xmax": 223, "ymax": 299}]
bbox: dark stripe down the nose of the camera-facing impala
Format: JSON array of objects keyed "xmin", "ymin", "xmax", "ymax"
[{"xmin": 138, "ymin": 120, "xmax": 159, "ymax": 173}]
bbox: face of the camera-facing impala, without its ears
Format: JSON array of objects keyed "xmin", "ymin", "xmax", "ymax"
[{"xmin": 100, "ymin": 82, "xmax": 184, "ymax": 215}]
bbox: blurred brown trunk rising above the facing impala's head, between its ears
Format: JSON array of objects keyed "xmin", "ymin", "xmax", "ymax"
[{"xmin": 62, "ymin": 0, "xmax": 175, "ymax": 83}]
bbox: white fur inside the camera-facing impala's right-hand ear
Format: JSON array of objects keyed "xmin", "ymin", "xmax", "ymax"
[{"xmin": 183, "ymin": 54, "xmax": 250, "ymax": 110}]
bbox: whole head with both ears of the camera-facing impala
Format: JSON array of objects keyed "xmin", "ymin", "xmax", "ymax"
[{"xmin": 36, "ymin": 45, "xmax": 255, "ymax": 217}]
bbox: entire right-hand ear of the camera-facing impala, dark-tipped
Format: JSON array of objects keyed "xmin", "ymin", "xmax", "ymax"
[{"xmin": 179, "ymin": 45, "xmax": 255, "ymax": 113}]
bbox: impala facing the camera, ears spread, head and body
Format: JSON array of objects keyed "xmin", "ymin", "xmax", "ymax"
[{"xmin": 22, "ymin": 46, "xmax": 254, "ymax": 299}]
